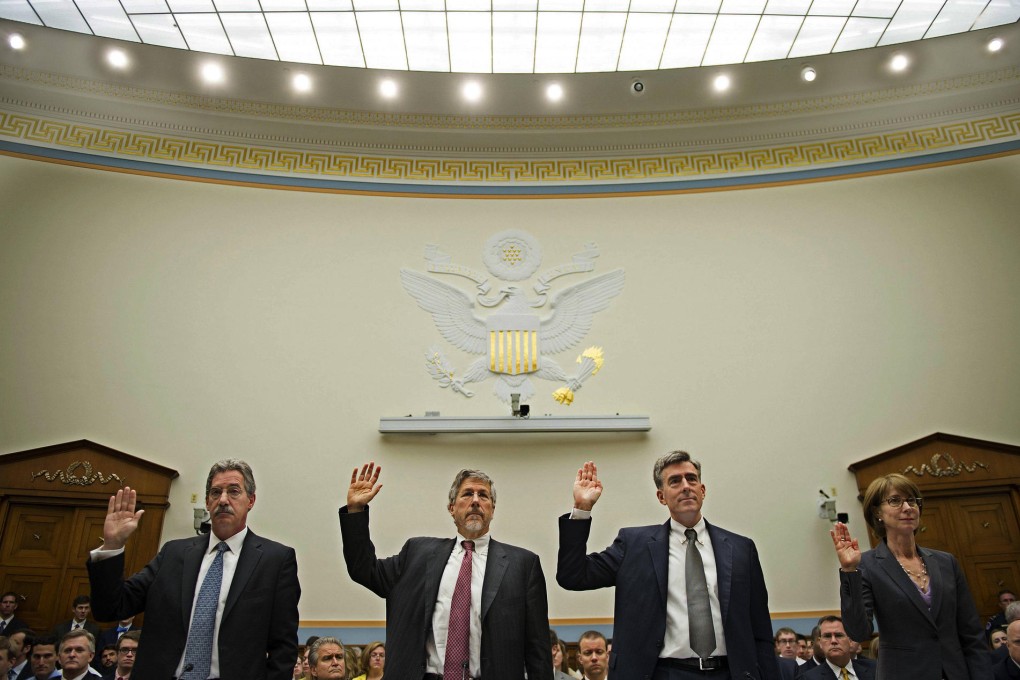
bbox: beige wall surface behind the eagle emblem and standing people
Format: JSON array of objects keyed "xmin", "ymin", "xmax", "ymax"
[{"xmin": 0, "ymin": 156, "xmax": 1020, "ymax": 620}]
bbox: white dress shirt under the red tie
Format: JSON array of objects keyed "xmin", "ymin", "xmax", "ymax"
[{"xmin": 425, "ymin": 533, "xmax": 489, "ymax": 678}]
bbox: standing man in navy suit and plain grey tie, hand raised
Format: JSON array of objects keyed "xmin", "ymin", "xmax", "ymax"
[{"xmin": 556, "ymin": 451, "xmax": 780, "ymax": 680}]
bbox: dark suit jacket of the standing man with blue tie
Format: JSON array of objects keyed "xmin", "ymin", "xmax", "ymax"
[{"xmin": 86, "ymin": 530, "xmax": 301, "ymax": 680}]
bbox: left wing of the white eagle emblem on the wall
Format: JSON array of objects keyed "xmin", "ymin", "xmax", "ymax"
[{"xmin": 400, "ymin": 269, "xmax": 487, "ymax": 354}]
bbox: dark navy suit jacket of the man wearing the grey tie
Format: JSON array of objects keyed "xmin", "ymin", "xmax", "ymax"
[{"xmin": 556, "ymin": 515, "xmax": 779, "ymax": 680}]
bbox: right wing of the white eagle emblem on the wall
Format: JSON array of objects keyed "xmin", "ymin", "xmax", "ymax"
[{"xmin": 539, "ymin": 269, "xmax": 623, "ymax": 354}]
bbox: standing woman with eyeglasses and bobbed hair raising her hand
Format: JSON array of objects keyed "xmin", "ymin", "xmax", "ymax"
[{"xmin": 829, "ymin": 473, "xmax": 991, "ymax": 680}]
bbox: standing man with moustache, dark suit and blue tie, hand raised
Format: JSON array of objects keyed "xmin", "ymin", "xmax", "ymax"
[{"xmin": 87, "ymin": 459, "xmax": 301, "ymax": 680}]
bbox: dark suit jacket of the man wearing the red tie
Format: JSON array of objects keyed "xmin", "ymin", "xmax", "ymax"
[{"xmin": 340, "ymin": 507, "xmax": 553, "ymax": 680}]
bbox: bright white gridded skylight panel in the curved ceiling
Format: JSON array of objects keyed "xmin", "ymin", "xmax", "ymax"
[{"xmin": 0, "ymin": 0, "xmax": 1020, "ymax": 73}]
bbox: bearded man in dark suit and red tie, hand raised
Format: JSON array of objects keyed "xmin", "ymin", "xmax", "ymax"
[{"xmin": 340, "ymin": 463, "xmax": 553, "ymax": 680}]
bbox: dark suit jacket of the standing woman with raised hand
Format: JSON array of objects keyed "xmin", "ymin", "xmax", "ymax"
[{"xmin": 839, "ymin": 541, "xmax": 991, "ymax": 680}]
